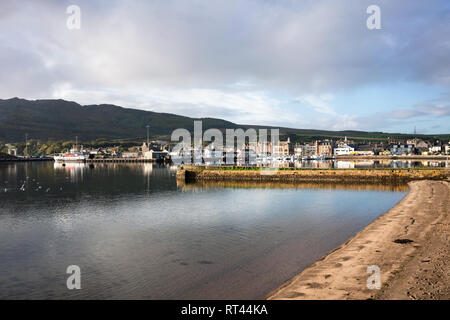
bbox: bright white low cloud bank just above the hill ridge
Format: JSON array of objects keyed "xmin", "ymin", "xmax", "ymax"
[{"xmin": 48, "ymin": 83, "xmax": 293, "ymax": 125}]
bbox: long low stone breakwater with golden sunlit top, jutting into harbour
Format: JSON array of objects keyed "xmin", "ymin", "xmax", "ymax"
[{"xmin": 177, "ymin": 166, "xmax": 450, "ymax": 183}]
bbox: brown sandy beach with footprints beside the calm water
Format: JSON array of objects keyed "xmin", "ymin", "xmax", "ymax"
[{"xmin": 267, "ymin": 181, "xmax": 450, "ymax": 299}]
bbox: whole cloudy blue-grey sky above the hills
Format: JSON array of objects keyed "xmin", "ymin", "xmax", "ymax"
[{"xmin": 0, "ymin": 0, "xmax": 450, "ymax": 134}]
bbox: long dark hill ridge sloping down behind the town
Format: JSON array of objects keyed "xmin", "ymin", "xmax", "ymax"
[{"xmin": 0, "ymin": 98, "xmax": 450, "ymax": 142}]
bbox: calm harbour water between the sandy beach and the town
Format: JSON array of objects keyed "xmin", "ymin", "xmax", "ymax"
[{"xmin": 0, "ymin": 162, "xmax": 406, "ymax": 299}]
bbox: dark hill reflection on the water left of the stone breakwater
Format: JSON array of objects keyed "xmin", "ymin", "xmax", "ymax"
[{"xmin": 0, "ymin": 162, "xmax": 176, "ymax": 200}]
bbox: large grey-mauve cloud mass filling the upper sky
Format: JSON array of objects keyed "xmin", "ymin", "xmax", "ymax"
[{"xmin": 0, "ymin": 0, "xmax": 450, "ymax": 93}]
